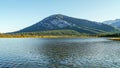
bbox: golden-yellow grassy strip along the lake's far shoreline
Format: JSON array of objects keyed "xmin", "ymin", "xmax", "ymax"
[{"xmin": 0, "ymin": 35, "xmax": 120, "ymax": 41}]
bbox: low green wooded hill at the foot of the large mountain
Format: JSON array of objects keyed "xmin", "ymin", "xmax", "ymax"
[{"xmin": 16, "ymin": 30, "xmax": 81, "ymax": 36}]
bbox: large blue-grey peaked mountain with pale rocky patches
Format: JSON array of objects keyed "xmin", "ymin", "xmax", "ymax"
[{"xmin": 14, "ymin": 14, "xmax": 116, "ymax": 34}]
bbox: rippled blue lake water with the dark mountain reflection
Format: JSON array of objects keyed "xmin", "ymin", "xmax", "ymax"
[{"xmin": 0, "ymin": 38, "xmax": 120, "ymax": 68}]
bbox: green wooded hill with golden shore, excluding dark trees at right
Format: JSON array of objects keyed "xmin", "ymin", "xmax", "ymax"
[{"xmin": 0, "ymin": 30, "xmax": 92, "ymax": 38}]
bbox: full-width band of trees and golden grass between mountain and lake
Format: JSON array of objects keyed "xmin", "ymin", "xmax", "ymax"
[{"xmin": 0, "ymin": 30, "xmax": 120, "ymax": 39}]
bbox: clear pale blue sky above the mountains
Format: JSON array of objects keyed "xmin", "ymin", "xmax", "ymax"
[{"xmin": 0, "ymin": 0, "xmax": 120, "ymax": 33}]
